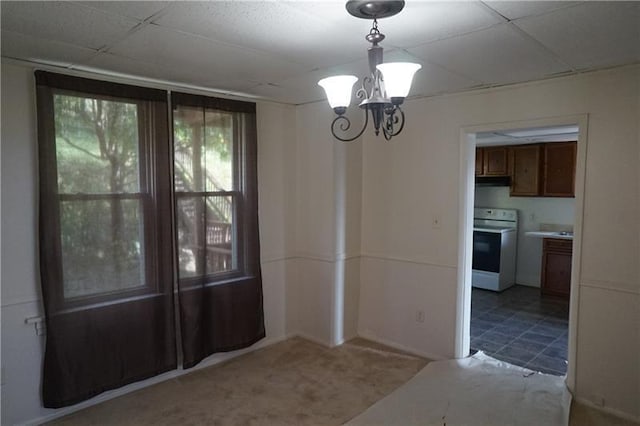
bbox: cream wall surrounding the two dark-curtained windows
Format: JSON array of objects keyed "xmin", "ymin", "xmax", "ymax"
[{"xmin": 1, "ymin": 62, "xmax": 295, "ymax": 424}]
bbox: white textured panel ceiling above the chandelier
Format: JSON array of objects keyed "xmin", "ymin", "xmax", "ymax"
[{"xmin": 0, "ymin": 0, "xmax": 640, "ymax": 104}]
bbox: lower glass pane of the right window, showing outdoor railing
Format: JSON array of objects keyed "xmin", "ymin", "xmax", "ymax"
[{"xmin": 177, "ymin": 196, "xmax": 237, "ymax": 278}]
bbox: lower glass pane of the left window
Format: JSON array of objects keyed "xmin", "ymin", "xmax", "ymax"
[{"xmin": 60, "ymin": 199, "xmax": 145, "ymax": 298}]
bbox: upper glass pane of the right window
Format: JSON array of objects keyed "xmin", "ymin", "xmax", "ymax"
[{"xmin": 173, "ymin": 106, "xmax": 234, "ymax": 192}]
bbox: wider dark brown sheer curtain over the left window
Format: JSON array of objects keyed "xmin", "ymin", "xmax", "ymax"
[{"xmin": 35, "ymin": 71, "xmax": 177, "ymax": 408}]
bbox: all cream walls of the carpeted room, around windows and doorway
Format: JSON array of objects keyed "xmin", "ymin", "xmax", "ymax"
[{"xmin": 2, "ymin": 60, "xmax": 640, "ymax": 423}]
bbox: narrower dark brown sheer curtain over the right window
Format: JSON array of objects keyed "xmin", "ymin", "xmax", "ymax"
[{"xmin": 171, "ymin": 93, "xmax": 265, "ymax": 368}]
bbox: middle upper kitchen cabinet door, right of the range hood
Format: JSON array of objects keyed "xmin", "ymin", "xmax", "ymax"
[{"xmin": 510, "ymin": 144, "xmax": 542, "ymax": 196}]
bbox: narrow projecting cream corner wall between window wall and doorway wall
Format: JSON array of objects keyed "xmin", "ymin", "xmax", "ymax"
[{"xmin": 287, "ymin": 103, "xmax": 362, "ymax": 346}]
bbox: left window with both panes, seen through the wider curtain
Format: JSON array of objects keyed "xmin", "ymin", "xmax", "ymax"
[{"xmin": 53, "ymin": 91, "xmax": 153, "ymax": 300}]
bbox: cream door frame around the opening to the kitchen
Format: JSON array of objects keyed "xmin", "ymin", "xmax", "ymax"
[{"xmin": 454, "ymin": 114, "xmax": 589, "ymax": 391}]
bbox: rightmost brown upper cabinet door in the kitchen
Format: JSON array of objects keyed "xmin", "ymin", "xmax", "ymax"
[{"xmin": 542, "ymin": 142, "xmax": 577, "ymax": 197}]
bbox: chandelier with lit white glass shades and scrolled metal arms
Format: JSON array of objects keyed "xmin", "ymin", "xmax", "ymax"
[{"xmin": 318, "ymin": 0, "xmax": 422, "ymax": 142}]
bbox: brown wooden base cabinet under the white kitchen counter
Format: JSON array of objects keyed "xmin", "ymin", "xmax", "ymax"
[{"xmin": 541, "ymin": 238, "xmax": 573, "ymax": 299}]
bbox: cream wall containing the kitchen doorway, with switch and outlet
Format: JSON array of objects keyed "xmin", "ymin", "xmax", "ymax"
[{"xmin": 359, "ymin": 66, "xmax": 640, "ymax": 418}]
